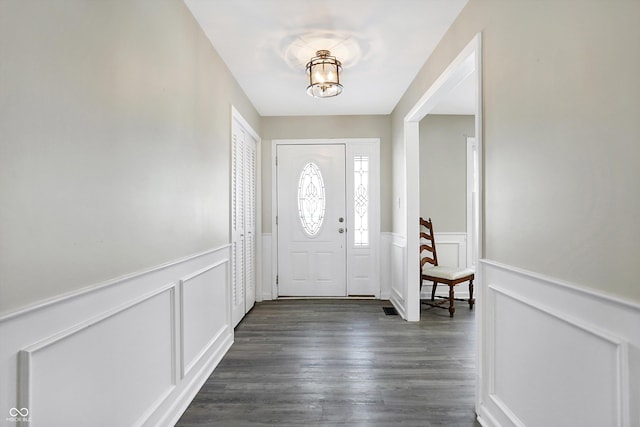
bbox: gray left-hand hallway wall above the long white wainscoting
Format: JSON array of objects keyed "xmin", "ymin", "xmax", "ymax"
[{"xmin": 0, "ymin": 0, "xmax": 260, "ymax": 313}]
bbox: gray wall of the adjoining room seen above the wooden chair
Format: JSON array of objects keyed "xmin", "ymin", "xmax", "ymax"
[{"xmin": 420, "ymin": 114, "xmax": 475, "ymax": 233}]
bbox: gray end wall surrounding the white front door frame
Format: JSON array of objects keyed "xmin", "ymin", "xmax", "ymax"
[{"xmin": 260, "ymin": 115, "xmax": 391, "ymax": 233}]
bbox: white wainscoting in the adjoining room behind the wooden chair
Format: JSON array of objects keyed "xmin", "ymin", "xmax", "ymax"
[{"xmin": 420, "ymin": 233, "xmax": 469, "ymax": 299}]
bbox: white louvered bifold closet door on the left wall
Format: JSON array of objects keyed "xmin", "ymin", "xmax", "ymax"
[{"xmin": 231, "ymin": 120, "xmax": 256, "ymax": 327}]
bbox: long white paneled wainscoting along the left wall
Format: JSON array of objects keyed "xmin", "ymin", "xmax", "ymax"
[{"xmin": 0, "ymin": 246, "xmax": 233, "ymax": 427}]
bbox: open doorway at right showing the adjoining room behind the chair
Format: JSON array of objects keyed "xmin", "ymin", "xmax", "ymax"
[{"xmin": 419, "ymin": 117, "xmax": 477, "ymax": 300}]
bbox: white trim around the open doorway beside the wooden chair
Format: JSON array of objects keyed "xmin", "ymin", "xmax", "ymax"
[{"xmin": 403, "ymin": 33, "xmax": 483, "ymax": 321}]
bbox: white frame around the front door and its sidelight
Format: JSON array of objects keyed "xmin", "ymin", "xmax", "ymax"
[{"xmin": 271, "ymin": 138, "xmax": 381, "ymax": 299}]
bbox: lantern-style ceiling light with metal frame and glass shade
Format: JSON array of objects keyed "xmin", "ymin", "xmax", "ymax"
[{"xmin": 307, "ymin": 50, "xmax": 342, "ymax": 98}]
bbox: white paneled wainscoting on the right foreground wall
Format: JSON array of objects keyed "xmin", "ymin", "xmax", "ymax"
[{"xmin": 477, "ymin": 260, "xmax": 640, "ymax": 427}]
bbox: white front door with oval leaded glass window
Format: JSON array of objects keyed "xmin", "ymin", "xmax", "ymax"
[{"xmin": 276, "ymin": 144, "xmax": 347, "ymax": 297}]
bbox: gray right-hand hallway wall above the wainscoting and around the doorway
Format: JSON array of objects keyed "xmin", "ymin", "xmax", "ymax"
[{"xmin": 392, "ymin": 0, "xmax": 640, "ymax": 301}]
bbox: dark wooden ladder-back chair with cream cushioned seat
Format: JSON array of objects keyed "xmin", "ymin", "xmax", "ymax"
[{"xmin": 420, "ymin": 218, "xmax": 476, "ymax": 317}]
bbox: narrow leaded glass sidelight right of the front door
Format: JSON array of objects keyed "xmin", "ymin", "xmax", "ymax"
[{"xmin": 353, "ymin": 156, "xmax": 369, "ymax": 246}]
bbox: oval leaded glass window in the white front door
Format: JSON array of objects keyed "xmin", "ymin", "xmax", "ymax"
[{"xmin": 298, "ymin": 162, "xmax": 326, "ymax": 237}]
